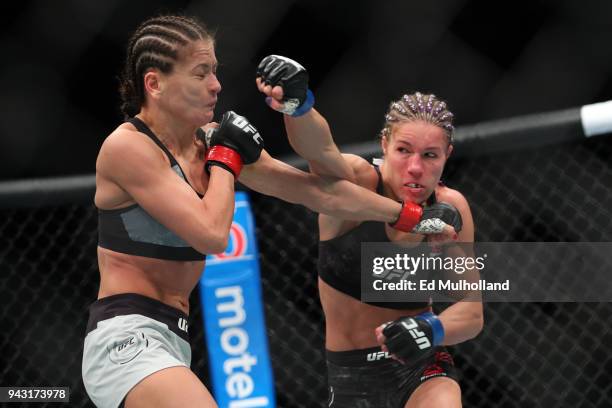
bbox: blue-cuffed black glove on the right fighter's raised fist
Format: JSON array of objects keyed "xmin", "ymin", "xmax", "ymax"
[{"xmin": 256, "ymin": 55, "xmax": 314, "ymax": 116}]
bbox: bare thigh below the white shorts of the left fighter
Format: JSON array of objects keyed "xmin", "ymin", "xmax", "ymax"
[{"xmin": 125, "ymin": 366, "xmax": 217, "ymax": 408}]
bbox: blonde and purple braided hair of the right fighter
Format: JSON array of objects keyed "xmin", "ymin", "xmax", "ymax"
[{"xmin": 380, "ymin": 92, "xmax": 455, "ymax": 144}]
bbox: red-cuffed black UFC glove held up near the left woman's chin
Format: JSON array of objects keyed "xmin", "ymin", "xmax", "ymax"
[{"xmin": 205, "ymin": 111, "xmax": 264, "ymax": 178}]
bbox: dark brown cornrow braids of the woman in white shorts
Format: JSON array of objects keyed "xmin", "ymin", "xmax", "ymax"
[{"xmin": 119, "ymin": 15, "xmax": 214, "ymax": 120}]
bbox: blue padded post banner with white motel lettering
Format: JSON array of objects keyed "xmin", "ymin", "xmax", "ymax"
[{"xmin": 200, "ymin": 192, "xmax": 276, "ymax": 408}]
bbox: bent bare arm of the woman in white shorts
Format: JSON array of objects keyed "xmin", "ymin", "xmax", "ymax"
[{"xmin": 96, "ymin": 129, "xmax": 234, "ymax": 253}]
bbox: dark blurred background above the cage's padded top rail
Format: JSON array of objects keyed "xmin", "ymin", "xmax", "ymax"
[{"xmin": 0, "ymin": 0, "xmax": 612, "ymax": 180}]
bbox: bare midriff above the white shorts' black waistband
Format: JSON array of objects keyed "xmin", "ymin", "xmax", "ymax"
[{"xmin": 98, "ymin": 247, "xmax": 204, "ymax": 314}]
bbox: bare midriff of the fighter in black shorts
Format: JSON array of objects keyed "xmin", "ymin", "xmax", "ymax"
[{"xmin": 319, "ymin": 278, "xmax": 430, "ymax": 351}]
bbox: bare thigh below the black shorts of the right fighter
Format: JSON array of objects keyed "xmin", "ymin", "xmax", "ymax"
[{"xmin": 405, "ymin": 377, "xmax": 461, "ymax": 408}]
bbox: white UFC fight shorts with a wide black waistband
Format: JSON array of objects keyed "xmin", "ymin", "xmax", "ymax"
[{"xmin": 82, "ymin": 293, "xmax": 191, "ymax": 408}]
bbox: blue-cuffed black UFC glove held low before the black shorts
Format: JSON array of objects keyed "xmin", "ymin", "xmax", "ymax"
[{"xmin": 382, "ymin": 312, "xmax": 444, "ymax": 363}]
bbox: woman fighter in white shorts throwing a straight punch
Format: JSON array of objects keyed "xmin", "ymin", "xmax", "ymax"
[{"xmin": 82, "ymin": 16, "xmax": 464, "ymax": 408}]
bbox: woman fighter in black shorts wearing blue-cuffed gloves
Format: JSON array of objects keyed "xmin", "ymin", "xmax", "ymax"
[{"xmin": 256, "ymin": 55, "xmax": 483, "ymax": 408}]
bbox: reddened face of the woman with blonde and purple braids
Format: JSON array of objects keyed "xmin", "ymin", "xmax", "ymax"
[{"xmin": 382, "ymin": 121, "xmax": 452, "ymax": 204}]
